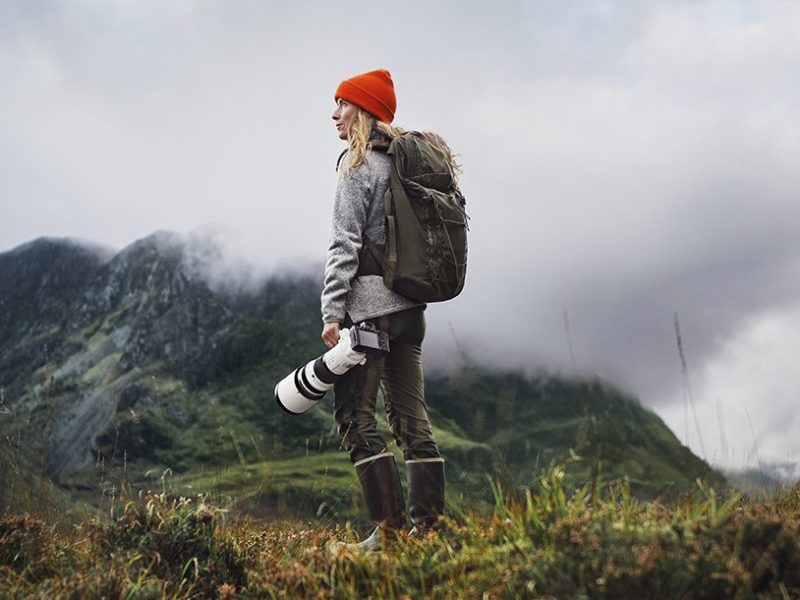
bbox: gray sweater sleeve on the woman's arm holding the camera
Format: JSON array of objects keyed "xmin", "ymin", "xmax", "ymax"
[{"xmin": 321, "ymin": 164, "xmax": 370, "ymax": 323}]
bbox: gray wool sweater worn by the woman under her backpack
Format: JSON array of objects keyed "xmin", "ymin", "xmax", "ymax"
[{"xmin": 321, "ymin": 150, "xmax": 420, "ymax": 323}]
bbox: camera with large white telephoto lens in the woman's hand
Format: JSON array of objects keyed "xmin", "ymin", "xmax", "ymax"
[{"xmin": 275, "ymin": 323, "xmax": 389, "ymax": 415}]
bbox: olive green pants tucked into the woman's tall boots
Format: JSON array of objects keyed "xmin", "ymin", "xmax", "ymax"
[{"xmin": 333, "ymin": 307, "xmax": 441, "ymax": 463}]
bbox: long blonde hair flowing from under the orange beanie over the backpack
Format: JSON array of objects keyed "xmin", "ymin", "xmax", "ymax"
[{"xmin": 345, "ymin": 107, "xmax": 461, "ymax": 184}]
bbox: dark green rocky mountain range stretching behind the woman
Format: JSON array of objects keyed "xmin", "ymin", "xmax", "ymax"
[{"xmin": 0, "ymin": 232, "xmax": 722, "ymax": 509}]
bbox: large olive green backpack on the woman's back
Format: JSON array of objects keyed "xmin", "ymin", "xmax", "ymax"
[{"xmin": 359, "ymin": 132, "xmax": 468, "ymax": 302}]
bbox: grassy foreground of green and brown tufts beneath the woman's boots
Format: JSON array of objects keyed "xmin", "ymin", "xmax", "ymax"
[{"xmin": 0, "ymin": 468, "xmax": 800, "ymax": 599}]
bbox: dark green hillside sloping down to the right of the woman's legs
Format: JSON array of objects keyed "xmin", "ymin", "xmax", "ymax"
[{"xmin": 428, "ymin": 368, "xmax": 723, "ymax": 497}]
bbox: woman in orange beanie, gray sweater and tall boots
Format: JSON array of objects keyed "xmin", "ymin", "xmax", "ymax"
[{"xmin": 321, "ymin": 69, "xmax": 457, "ymax": 551}]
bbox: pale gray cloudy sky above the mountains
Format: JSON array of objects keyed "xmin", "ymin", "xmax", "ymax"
[{"xmin": 0, "ymin": 0, "xmax": 800, "ymax": 478}]
